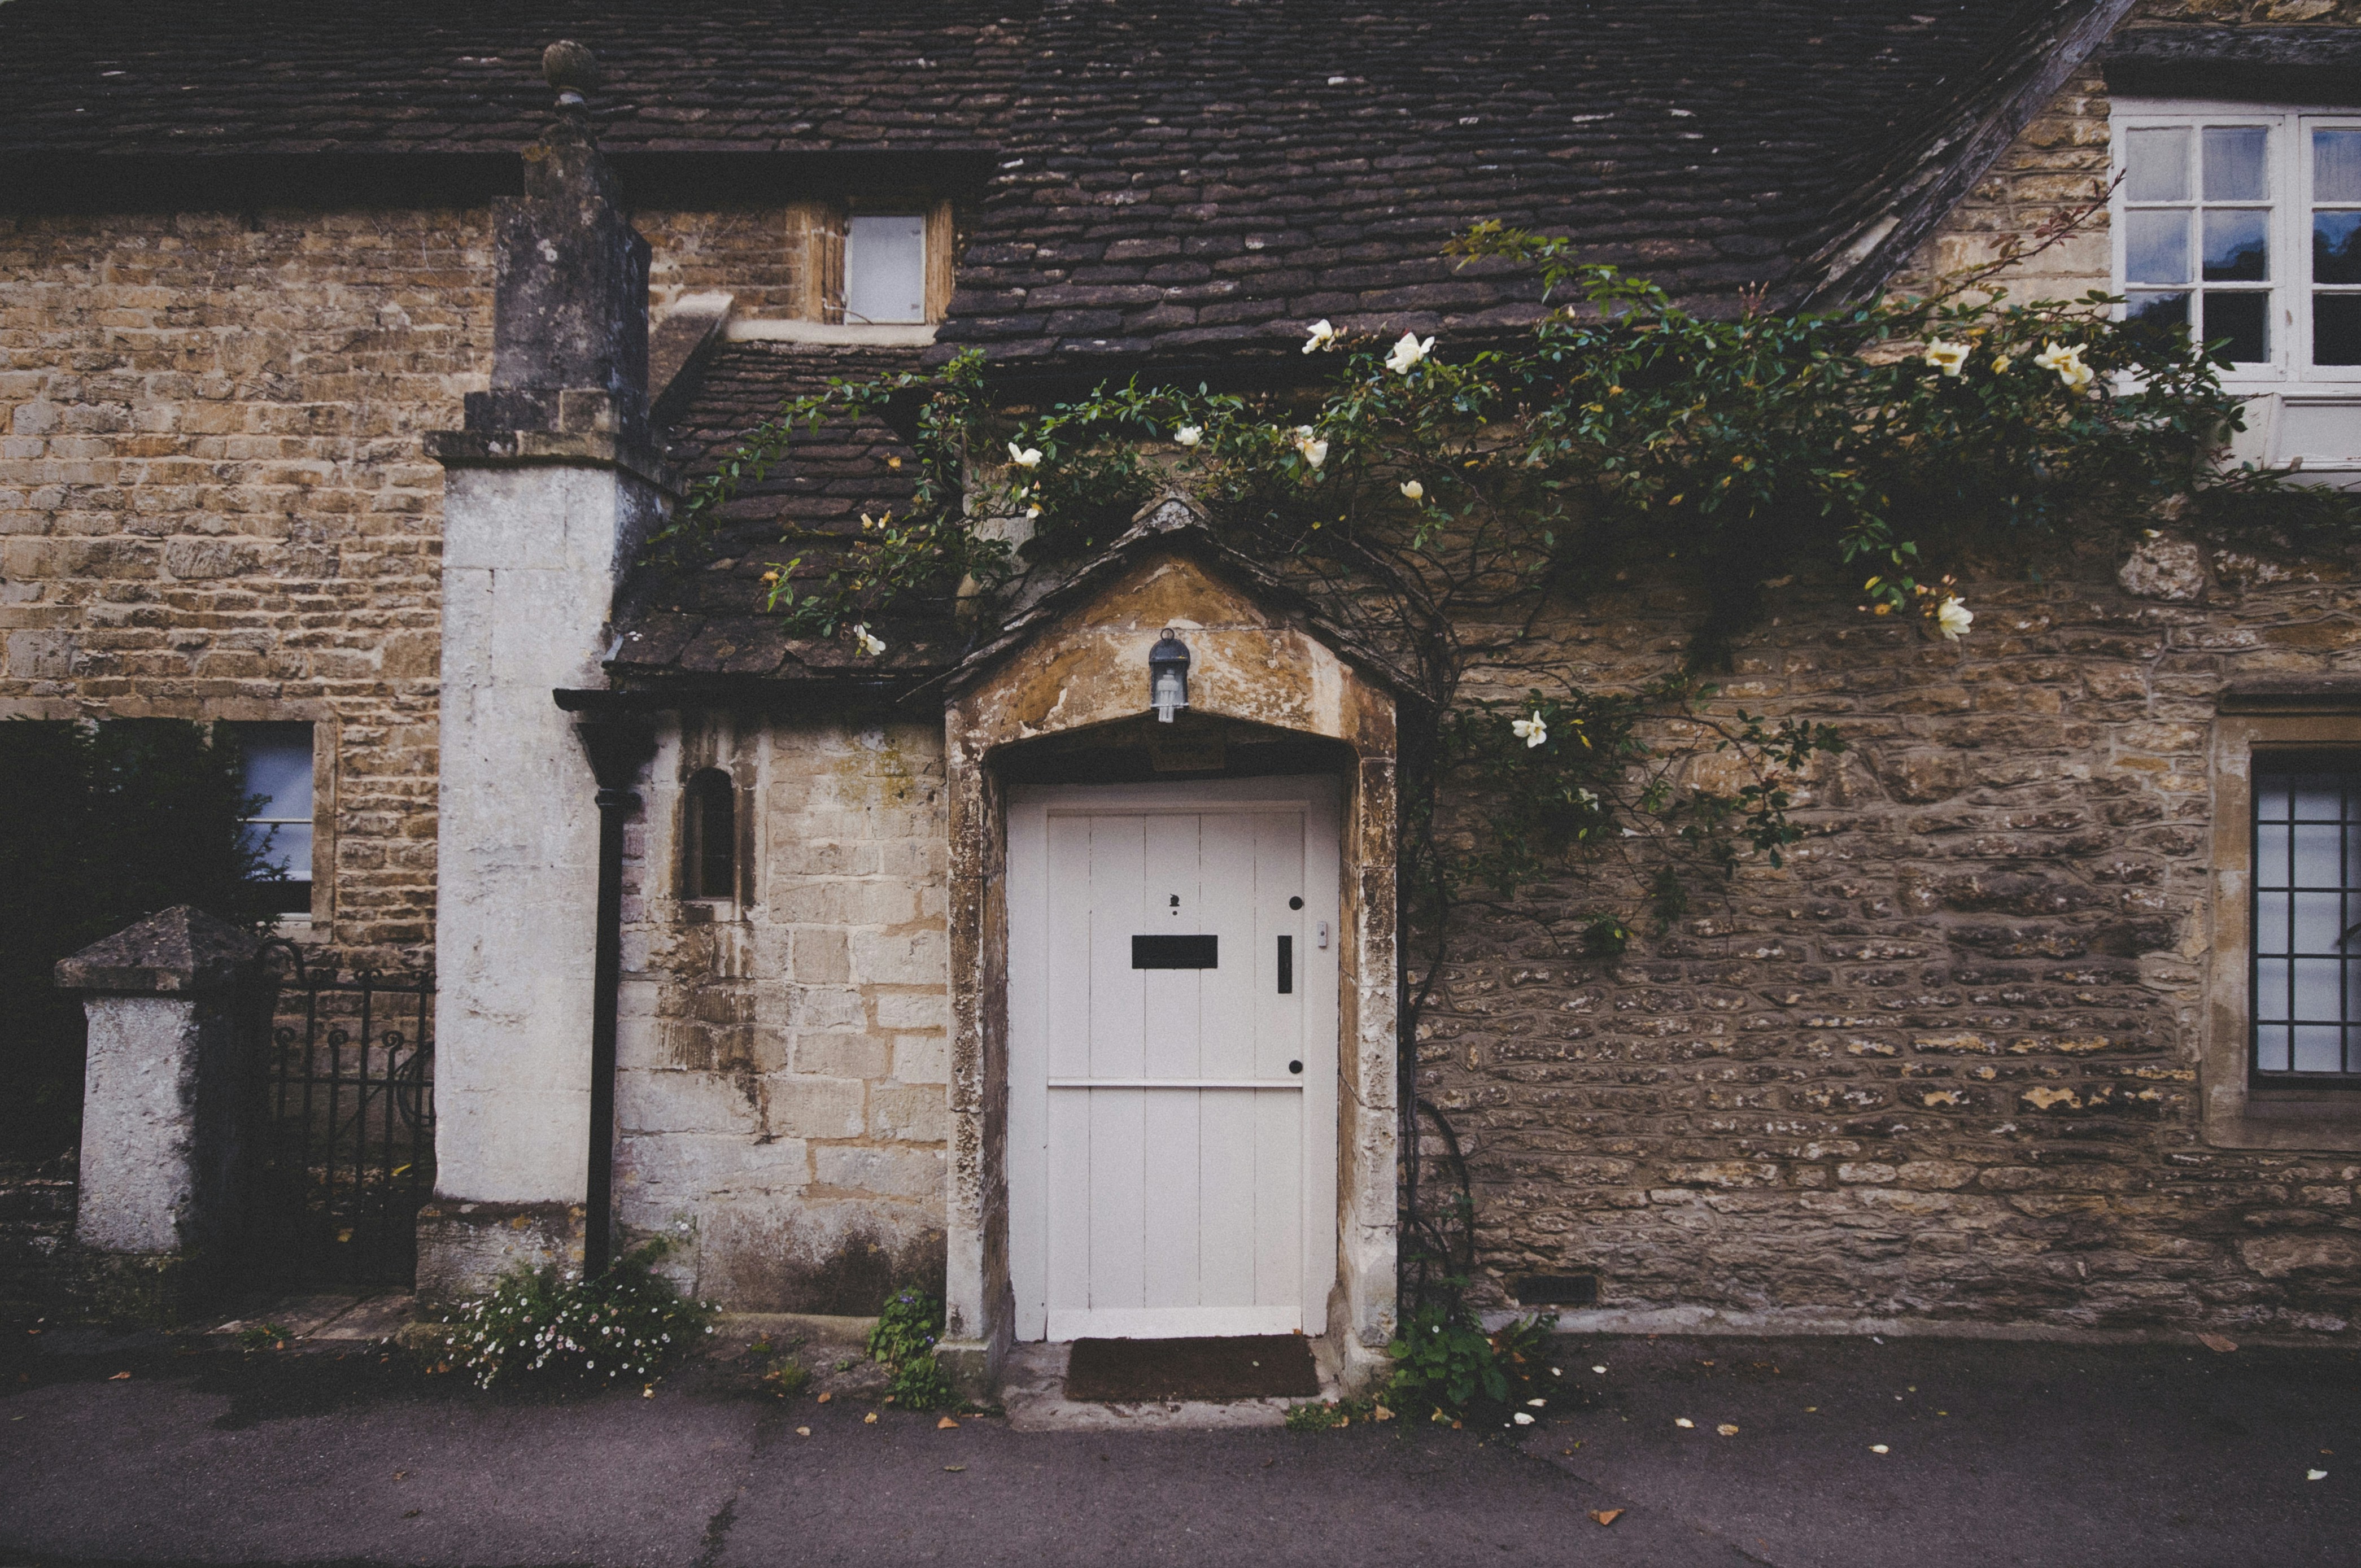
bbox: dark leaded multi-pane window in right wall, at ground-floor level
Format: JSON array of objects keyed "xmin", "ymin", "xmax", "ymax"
[{"xmin": 2253, "ymin": 753, "xmax": 2361, "ymax": 1084}]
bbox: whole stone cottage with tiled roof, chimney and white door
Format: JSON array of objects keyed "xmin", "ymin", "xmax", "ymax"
[{"xmin": 14, "ymin": 0, "xmax": 2361, "ymax": 1377}]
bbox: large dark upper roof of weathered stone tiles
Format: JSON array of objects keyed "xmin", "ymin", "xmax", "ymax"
[{"xmin": 0, "ymin": 0, "xmax": 2125, "ymax": 354}]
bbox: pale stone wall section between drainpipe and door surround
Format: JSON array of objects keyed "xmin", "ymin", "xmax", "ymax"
[{"xmin": 616, "ymin": 713, "xmax": 949, "ymax": 1313}]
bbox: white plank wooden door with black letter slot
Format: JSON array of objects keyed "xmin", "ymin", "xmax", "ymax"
[{"xmin": 1008, "ymin": 779, "xmax": 1339, "ymax": 1339}]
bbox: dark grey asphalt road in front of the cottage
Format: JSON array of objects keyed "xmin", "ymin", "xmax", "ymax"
[{"xmin": 0, "ymin": 1334, "xmax": 2361, "ymax": 1568}]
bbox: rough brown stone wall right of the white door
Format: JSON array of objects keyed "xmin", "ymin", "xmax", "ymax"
[{"xmin": 1419, "ymin": 539, "xmax": 2361, "ymax": 1334}]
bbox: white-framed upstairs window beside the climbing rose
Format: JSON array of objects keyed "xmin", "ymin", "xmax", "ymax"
[{"xmin": 2111, "ymin": 99, "xmax": 2361, "ymax": 470}]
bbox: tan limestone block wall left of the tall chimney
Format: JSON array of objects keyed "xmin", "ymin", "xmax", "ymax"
[{"xmin": 0, "ymin": 208, "xmax": 800, "ymax": 966}]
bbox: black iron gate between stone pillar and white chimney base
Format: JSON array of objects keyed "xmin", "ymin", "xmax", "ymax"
[{"xmin": 248, "ymin": 940, "xmax": 434, "ymax": 1287}]
